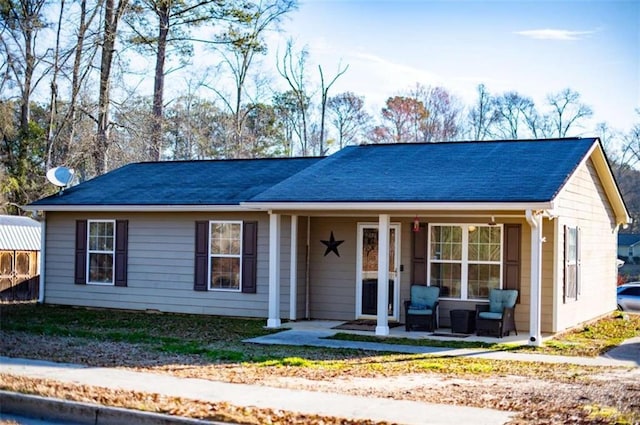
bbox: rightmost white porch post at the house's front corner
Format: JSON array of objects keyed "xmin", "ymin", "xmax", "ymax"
[{"xmin": 526, "ymin": 210, "xmax": 544, "ymax": 347}]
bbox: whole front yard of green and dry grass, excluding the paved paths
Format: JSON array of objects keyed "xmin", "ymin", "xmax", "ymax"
[{"xmin": 0, "ymin": 304, "xmax": 640, "ymax": 425}]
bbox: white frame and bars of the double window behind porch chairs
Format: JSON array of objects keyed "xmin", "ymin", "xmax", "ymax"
[{"xmin": 427, "ymin": 223, "xmax": 504, "ymax": 302}]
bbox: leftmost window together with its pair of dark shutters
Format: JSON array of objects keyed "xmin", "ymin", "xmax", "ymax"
[{"xmin": 75, "ymin": 220, "xmax": 129, "ymax": 286}]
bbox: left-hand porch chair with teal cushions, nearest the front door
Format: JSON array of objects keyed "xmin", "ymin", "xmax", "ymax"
[{"xmin": 404, "ymin": 285, "xmax": 440, "ymax": 332}]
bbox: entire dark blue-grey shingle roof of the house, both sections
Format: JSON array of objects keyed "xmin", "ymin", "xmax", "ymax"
[{"xmin": 31, "ymin": 138, "xmax": 597, "ymax": 207}]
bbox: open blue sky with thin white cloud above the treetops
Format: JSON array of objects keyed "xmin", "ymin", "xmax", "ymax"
[{"xmin": 271, "ymin": 0, "xmax": 640, "ymax": 131}]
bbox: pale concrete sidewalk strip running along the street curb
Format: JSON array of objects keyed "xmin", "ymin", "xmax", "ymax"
[{"xmin": 0, "ymin": 356, "xmax": 513, "ymax": 425}]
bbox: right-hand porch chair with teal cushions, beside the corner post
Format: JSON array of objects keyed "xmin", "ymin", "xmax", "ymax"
[{"xmin": 476, "ymin": 289, "xmax": 518, "ymax": 338}]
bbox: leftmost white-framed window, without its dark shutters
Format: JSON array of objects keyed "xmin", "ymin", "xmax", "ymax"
[{"xmin": 87, "ymin": 220, "xmax": 115, "ymax": 285}]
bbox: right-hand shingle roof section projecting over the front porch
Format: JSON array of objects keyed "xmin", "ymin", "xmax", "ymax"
[{"xmin": 251, "ymin": 138, "xmax": 597, "ymax": 202}]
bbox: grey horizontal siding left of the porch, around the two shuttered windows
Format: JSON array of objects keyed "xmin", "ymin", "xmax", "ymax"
[{"xmin": 45, "ymin": 212, "xmax": 290, "ymax": 317}]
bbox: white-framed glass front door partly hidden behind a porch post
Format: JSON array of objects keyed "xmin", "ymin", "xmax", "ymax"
[{"xmin": 356, "ymin": 223, "xmax": 400, "ymax": 320}]
